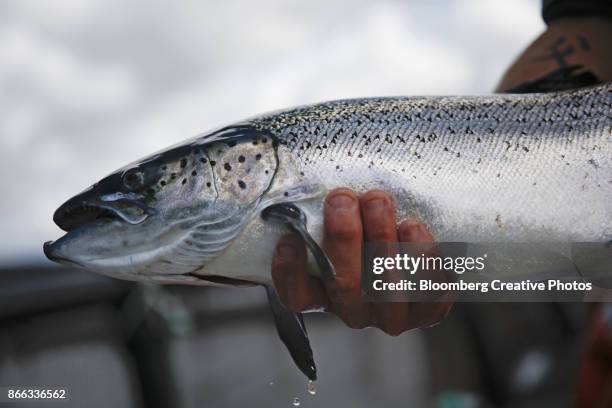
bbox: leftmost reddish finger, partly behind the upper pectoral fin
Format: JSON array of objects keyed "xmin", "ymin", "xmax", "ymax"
[{"xmin": 272, "ymin": 234, "xmax": 327, "ymax": 312}]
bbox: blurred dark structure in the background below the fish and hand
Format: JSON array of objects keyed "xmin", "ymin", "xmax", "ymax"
[{"xmin": 0, "ymin": 267, "xmax": 588, "ymax": 408}]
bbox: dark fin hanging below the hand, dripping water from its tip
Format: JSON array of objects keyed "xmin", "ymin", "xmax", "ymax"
[{"xmin": 265, "ymin": 286, "xmax": 317, "ymax": 381}]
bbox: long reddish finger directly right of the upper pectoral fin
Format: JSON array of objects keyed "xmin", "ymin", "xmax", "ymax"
[{"xmin": 323, "ymin": 188, "xmax": 370, "ymax": 328}]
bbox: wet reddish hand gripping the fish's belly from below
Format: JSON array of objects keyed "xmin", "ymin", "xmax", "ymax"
[{"xmin": 272, "ymin": 188, "xmax": 452, "ymax": 336}]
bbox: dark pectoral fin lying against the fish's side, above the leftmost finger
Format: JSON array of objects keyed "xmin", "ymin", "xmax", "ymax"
[{"xmin": 261, "ymin": 203, "xmax": 336, "ymax": 279}]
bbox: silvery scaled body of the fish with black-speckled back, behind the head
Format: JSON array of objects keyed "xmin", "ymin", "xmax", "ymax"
[{"xmin": 252, "ymin": 85, "xmax": 612, "ymax": 241}]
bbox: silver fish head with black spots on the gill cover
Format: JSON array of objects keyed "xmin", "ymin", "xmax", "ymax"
[{"xmin": 44, "ymin": 127, "xmax": 278, "ymax": 283}]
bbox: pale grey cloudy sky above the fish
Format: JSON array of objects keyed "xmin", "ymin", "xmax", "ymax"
[{"xmin": 0, "ymin": 0, "xmax": 544, "ymax": 264}]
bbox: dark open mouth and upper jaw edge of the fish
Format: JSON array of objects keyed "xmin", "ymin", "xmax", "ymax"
[{"xmin": 53, "ymin": 200, "xmax": 148, "ymax": 232}]
